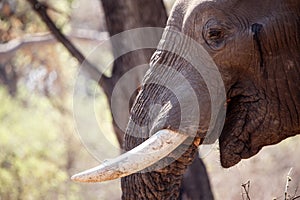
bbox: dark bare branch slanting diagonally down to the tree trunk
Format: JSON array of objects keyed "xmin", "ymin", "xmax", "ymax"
[{"xmin": 27, "ymin": 0, "xmax": 109, "ymax": 87}]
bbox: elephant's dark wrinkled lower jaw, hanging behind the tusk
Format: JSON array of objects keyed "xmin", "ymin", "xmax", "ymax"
[{"xmin": 219, "ymin": 96, "xmax": 296, "ymax": 168}]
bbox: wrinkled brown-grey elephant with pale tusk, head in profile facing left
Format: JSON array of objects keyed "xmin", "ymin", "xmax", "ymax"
[{"xmin": 72, "ymin": 0, "xmax": 300, "ymax": 199}]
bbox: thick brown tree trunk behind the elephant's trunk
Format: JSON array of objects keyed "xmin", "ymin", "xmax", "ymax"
[{"xmin": 101, "ymin": 0, "xmax": 213, "ymax": 200}]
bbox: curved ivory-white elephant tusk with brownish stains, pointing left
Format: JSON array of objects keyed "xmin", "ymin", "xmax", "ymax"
[{"xmin": 71, "ymin": 129, "xmax": 188, "ymax": 182}]
